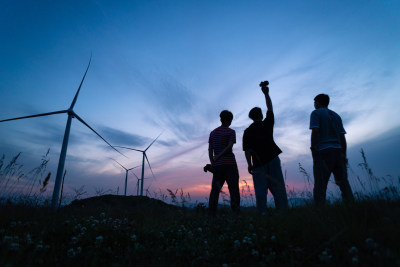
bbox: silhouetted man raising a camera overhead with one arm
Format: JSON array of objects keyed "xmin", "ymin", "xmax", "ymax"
[{"xmin": 243, "ymin": 81, "xmax": 288, "ymax": 214}]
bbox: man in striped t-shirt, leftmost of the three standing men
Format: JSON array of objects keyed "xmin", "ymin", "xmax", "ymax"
[{"xmin": 205, "ymin": 110, "xmax": 240, "ymax": 216}]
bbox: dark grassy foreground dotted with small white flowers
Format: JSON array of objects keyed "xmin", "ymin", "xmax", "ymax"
[{"xmin": 0, "ymin": 195, "xmax": 400, "ymax": 266}]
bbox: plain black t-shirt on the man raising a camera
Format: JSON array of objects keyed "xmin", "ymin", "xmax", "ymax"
[{"xmin": 243, "ymin": 111, "xmax": 282, "ymax": 167}]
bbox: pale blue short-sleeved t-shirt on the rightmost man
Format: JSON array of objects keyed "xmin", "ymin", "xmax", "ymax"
[{"xmin": 310, "ymin": 108, "xmax": 346, "ymax": 150}]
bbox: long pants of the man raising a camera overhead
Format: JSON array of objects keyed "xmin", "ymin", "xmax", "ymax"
[{"xmin": 253, "ymin": 157, "xmax": 288, "ymax": 214}]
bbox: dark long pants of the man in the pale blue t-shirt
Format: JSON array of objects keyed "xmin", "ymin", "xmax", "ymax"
[{"xmin": 313, "ymin": 148, "xmax": 354, "ymax": 205}]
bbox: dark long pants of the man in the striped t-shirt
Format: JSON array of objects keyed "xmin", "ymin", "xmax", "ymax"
[{"xmin": 208, "ymin": 164, "xmax": 240, "ymax": 215}]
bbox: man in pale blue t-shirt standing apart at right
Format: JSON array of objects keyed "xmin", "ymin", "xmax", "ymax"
[{"xmin": 310, "ymin": 94, "xmax": 354, "ymax": 205}]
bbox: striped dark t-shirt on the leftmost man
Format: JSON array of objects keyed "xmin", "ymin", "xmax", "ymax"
[{"xmin": 208, "ymin": 126, "xmax": 236, "ymax": 166}]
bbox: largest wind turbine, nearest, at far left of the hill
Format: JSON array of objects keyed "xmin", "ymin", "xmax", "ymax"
[{"xmin": 0, "ymin": 57, "xmax": 125, "ymax": 209}]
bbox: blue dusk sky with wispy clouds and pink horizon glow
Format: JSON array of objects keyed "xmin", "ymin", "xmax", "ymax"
[{"xmin": 0, "ymin": 0, "xmax": 400, "ymax": 201}]
